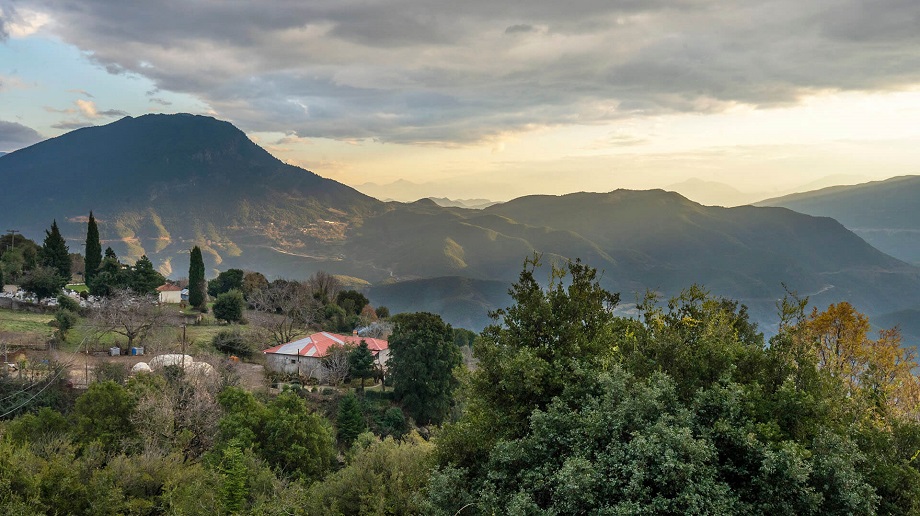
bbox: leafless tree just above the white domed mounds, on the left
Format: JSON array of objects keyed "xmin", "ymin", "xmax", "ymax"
[{"xmin": 92, "ymin": 289, "xmax": 164, "ymax": 348}]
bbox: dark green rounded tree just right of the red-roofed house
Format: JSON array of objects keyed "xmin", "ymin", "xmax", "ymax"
[{"xmin": 387, "ymin": 313, "xmax": 462, "ymax": 424}]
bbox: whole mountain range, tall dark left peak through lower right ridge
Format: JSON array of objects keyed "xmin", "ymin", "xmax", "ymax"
[{"xmin": 0, "ymin": 115, "xmax": 920, "ymax": 330}]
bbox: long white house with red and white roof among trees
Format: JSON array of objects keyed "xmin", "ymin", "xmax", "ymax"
[{"xmin": 262, "ymin": 331, "xmax": 390, "ymax": 381}]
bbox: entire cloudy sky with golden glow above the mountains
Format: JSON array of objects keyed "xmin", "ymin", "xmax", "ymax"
[{"xmin": 0, "ymin": 0, "xmax": 920, "ymax": 204}]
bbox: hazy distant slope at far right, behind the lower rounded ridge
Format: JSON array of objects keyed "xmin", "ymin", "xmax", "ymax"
[{"xmin": 757, "ymin": 176, "xmax": 920, "ymax": 264}]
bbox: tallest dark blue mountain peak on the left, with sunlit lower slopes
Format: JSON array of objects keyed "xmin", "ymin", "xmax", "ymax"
[{"xmin": 0, "ymin": 115, "xmax": 383, "ymax": 276}]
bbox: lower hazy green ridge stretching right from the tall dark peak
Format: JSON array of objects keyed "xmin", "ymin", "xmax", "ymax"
[{"xmin": 343, "ymin": 190, "xmax": 920, "ymax": 330}]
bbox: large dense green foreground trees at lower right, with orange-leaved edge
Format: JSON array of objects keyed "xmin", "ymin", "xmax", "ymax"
[{"xmin": 428, "ymin": 262, "xmax": 920, "ymax": 514}]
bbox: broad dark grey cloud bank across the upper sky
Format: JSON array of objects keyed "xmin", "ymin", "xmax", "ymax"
[{"xmin": 28, "ymin": 0, "xmax": 920, "ymax": 145}]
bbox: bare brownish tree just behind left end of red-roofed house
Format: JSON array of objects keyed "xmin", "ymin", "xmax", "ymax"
[{"xmin": 248, "ymin": 280, "xmax": 319, "ymax": 345}]
